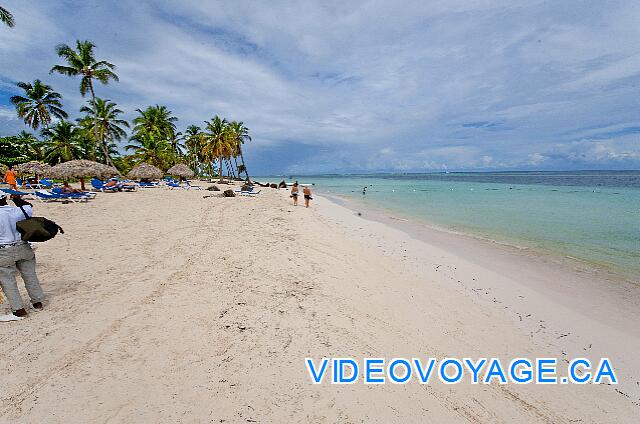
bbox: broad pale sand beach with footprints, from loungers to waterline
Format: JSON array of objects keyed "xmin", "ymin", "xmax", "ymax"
[{"xmin": 0, "ymin": 188, "xmax": 640, "ymax": 424}]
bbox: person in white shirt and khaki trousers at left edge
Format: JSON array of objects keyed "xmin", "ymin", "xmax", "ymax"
[{"xmin": 0, "ymin": 193, "xmax": 44, "ymax": 317}]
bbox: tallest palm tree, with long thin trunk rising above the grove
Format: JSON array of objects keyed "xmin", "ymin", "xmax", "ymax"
[{"xmin": 49, "ymin": 40, "xmax": 119, "ymax": 166}]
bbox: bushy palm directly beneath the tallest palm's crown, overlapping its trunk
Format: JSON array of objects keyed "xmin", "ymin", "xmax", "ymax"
[{"xmin": 78, "ymin": 97, "xmax": 129, "ymax": 161}]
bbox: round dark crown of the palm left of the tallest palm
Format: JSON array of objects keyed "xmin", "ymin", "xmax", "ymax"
[{"xmin": 10, "ymin": 79, "xmax": 68, "ymax": 130}]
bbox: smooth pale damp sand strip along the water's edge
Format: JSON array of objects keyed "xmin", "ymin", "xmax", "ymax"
[{"xmin": 312, "ymin": 193, "xmax": 640, "ymax": 398}]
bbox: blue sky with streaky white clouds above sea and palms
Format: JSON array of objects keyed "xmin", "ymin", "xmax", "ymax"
[{"xmin": 0, "ymin": 0, "xmax": 640, "ymax": 175}]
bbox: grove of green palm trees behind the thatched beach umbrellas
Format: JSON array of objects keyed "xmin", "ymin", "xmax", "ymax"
[{"xmin": 0, "ymin": 39, "xmax": 251, "ymax": 180}]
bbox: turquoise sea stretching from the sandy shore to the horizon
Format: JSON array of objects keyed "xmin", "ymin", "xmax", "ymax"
[{"xmin": 276, "ymin": 171, "xmax": 640, "ymax": 281}]
